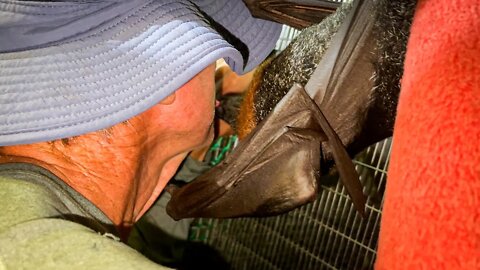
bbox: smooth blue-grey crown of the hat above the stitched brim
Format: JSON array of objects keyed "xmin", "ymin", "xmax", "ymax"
[{"xmin": 0, "ymin": 0, "xmax": 147, "ymax": 52}]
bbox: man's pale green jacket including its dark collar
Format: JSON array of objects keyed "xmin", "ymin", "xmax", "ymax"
[{"xmin": 0, "ymin": 163, "xmax": 170, "ymax": 270}]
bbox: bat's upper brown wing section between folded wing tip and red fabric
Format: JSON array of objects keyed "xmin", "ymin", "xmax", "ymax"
[{"xmin": 305, "ymin": 0, "xmax": 400, "ymax": 159}]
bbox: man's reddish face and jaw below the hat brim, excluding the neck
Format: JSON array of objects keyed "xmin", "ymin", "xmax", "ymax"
[{"xmin": 132, "ymin": 64, "xmax": 215, "ymax": 218}]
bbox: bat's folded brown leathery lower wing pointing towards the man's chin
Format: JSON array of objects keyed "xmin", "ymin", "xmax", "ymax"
[{"xmin": 167, "ymin": 85, "xmax": 364, "ymax": 219}]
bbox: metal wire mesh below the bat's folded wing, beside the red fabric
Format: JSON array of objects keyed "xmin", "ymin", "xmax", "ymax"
[{"xmin": 190, "ymin": 139, "xmax": 391, "ymax": 269}]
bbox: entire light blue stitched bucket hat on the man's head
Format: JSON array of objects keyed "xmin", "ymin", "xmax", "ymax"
[{"xmin": 0, "ymin": 0, "xmax": 281, "ymax": 145}]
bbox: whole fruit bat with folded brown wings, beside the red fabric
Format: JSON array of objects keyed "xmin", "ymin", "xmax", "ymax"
[{"xmin": 167, "ymin": 1, "xmax": 409, "ymax": 219}]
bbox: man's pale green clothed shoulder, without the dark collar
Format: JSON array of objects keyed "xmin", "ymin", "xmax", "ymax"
[{"xmin": 0, "ymin": 175, "xmax": 172, "ymax": 269}]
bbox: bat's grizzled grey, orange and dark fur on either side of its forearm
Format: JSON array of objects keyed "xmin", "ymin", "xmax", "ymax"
[{"xmin": 236, "ymin": 0, "xmax": 416, "ymax": 173}]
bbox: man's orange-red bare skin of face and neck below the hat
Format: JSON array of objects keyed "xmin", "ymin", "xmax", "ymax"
[{"xmin": 0, "ymin": 64, "xmax": 215, "ymax": 235}]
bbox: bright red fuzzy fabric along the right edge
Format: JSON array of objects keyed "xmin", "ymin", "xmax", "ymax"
[{"xmin": 376, "ymin": 0, "xmax": 480, "ymax": 270}]
